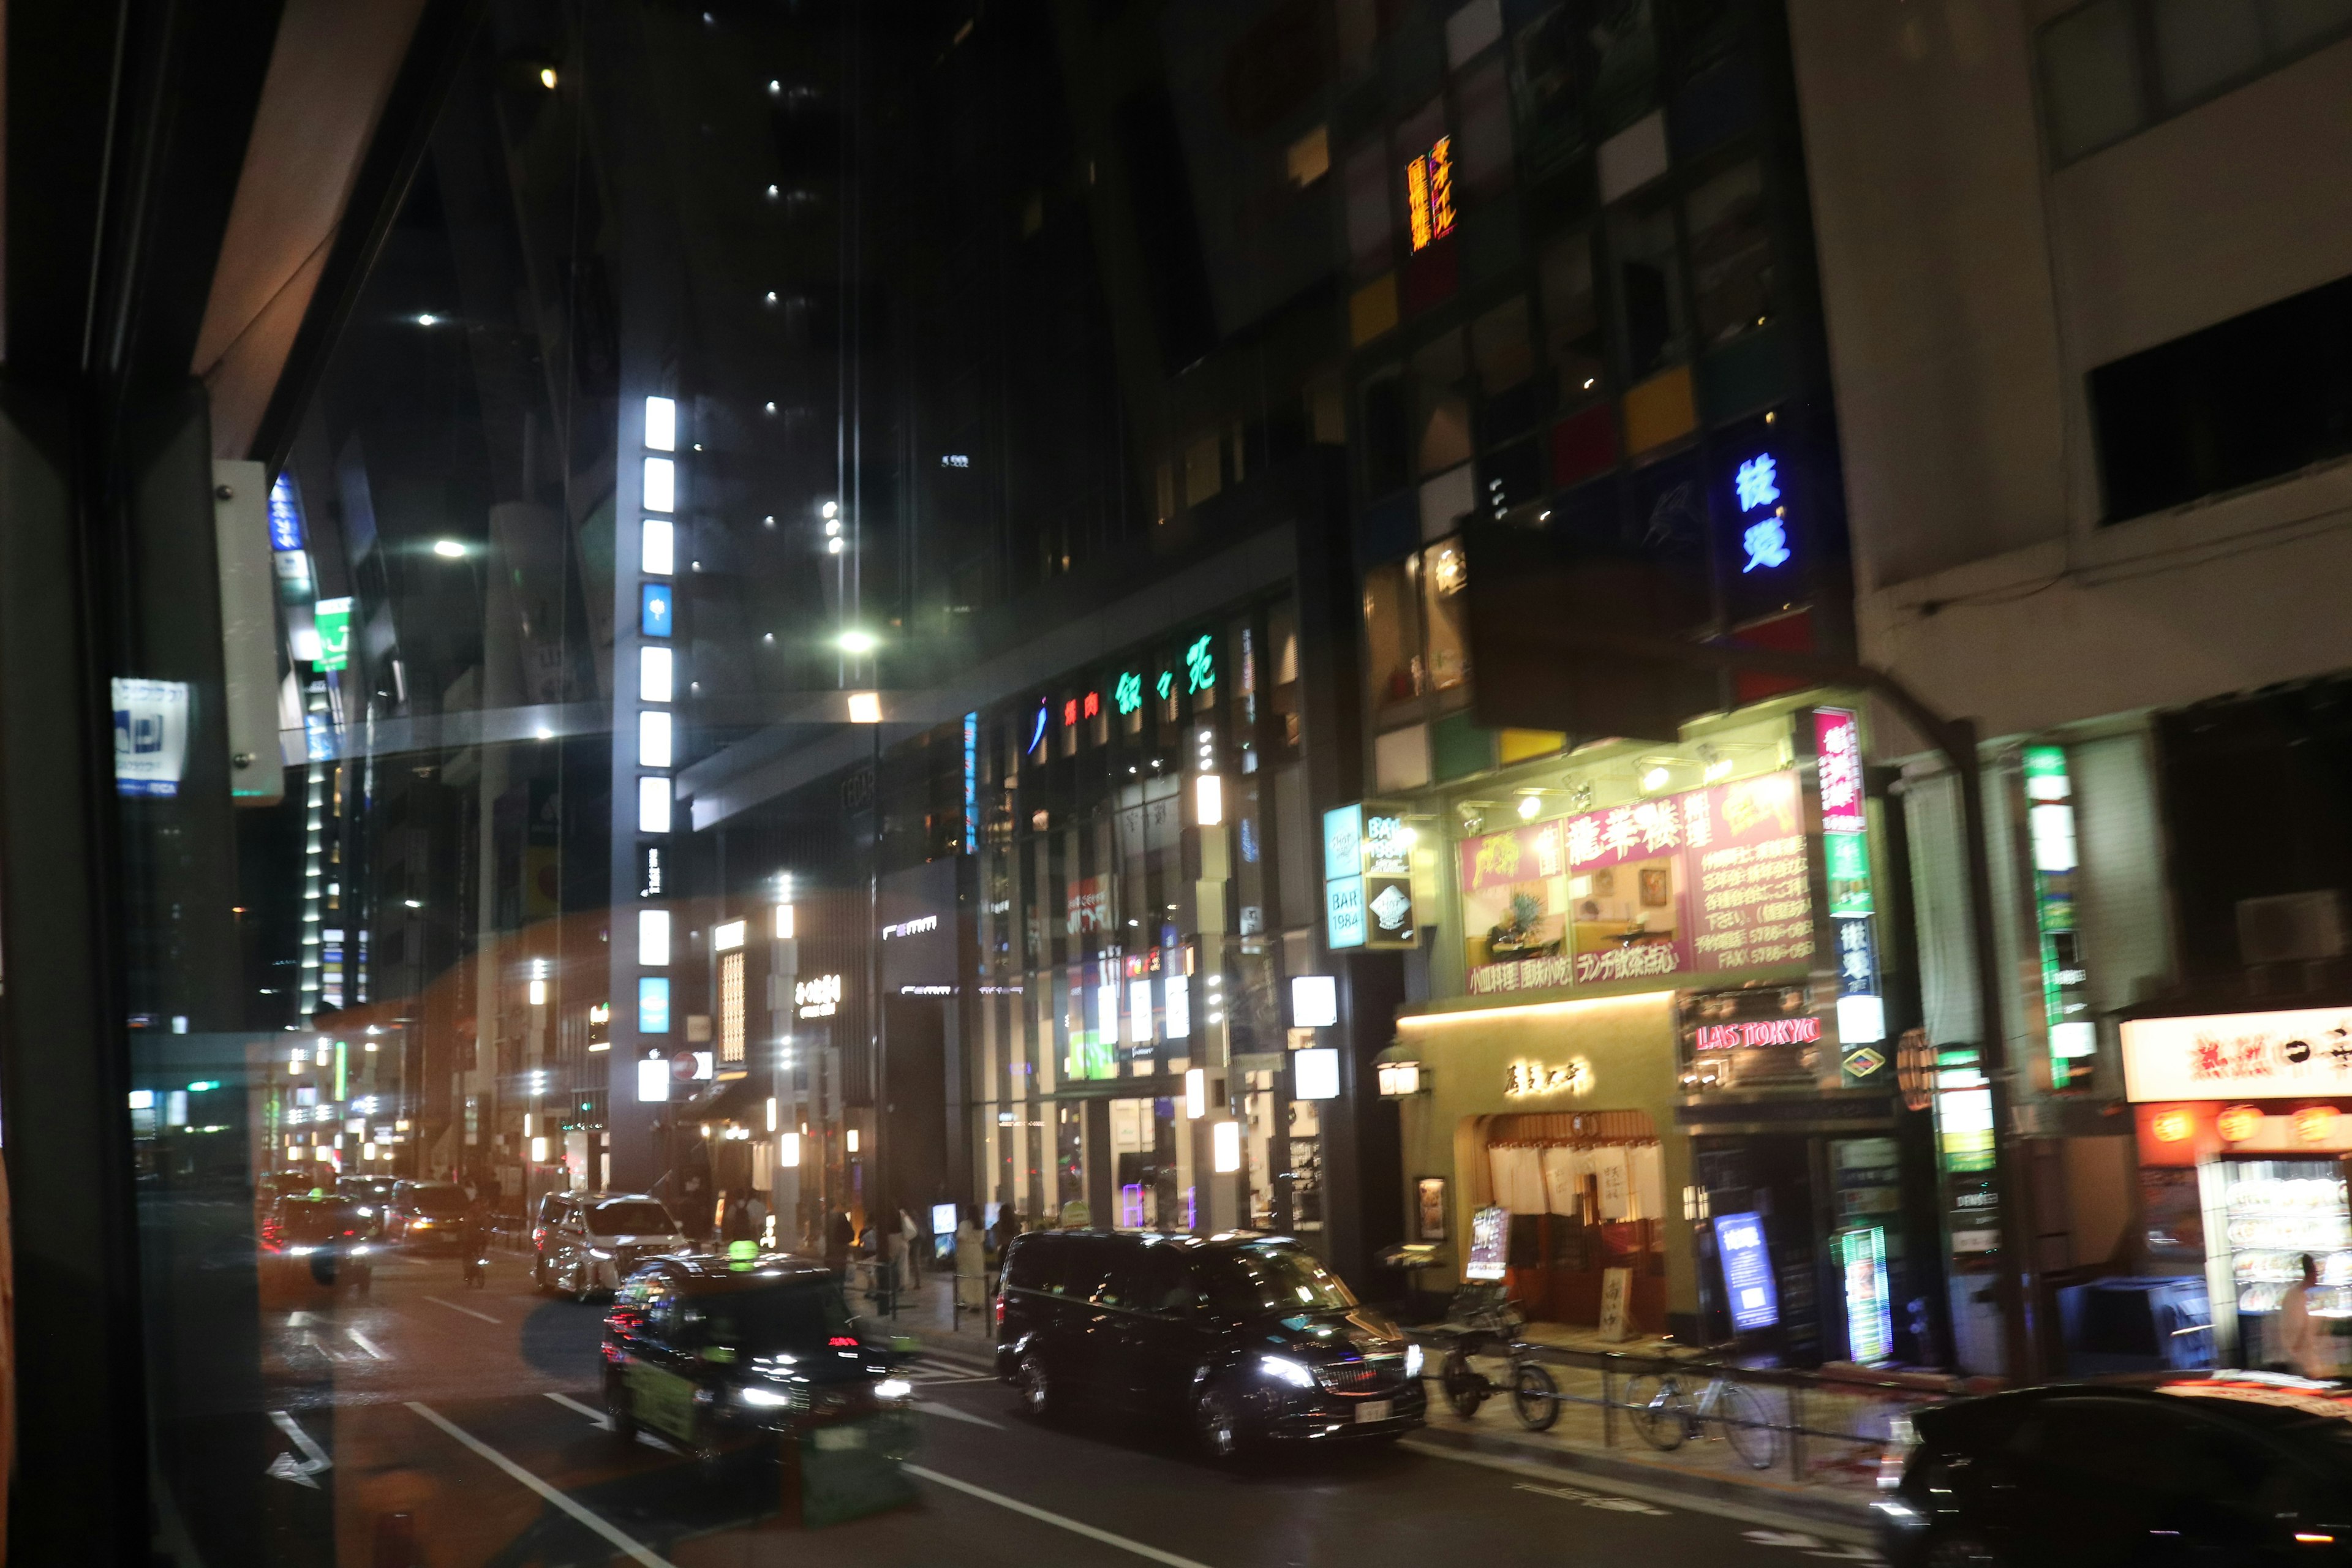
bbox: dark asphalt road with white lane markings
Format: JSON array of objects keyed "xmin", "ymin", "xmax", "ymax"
[{"xmin": 224, "ymin": 1256, "xmax": 1877, "ymax": 1568}]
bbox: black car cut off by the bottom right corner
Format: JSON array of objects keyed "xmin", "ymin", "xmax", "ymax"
[{"xmin": 1879, "ymin": 1373, "xmax": 2352, "ymax": 1568}]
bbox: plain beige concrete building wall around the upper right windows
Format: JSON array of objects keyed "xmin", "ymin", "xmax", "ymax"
[{"xmin": 1790, "ymin": 0, "xmax": 2352, "ymax": 750}]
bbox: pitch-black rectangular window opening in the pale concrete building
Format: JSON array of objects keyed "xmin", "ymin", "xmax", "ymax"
[{"xmin": 2091, "ymin": 263, "xmax": 2352, "ymax": 522}]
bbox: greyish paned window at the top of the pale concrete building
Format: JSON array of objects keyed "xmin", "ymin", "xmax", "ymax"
[{"xmin": 2037, "ymin": 0, "xmax": 2352, "ymax": 162}]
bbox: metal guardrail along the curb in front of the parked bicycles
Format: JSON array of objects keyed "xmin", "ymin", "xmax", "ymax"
[{"xmin": 1414, "ymin": 1330, "xmax": 1966, "ymax": 1483}]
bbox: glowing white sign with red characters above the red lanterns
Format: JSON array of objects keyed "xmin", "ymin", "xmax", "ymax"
[{"xmin": 2124, "ymin": 1009, "xmax": 2352, "ymax": 1100}]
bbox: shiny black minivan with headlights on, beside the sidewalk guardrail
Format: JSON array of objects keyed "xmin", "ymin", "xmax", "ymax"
[{"xmin": 997, "ymin": 1229, "xmax": 1428, "ymax": 1458}]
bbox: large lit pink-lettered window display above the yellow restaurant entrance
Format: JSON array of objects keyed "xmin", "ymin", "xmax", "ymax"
[{"xmin": 1461, "ymin": 774, "xmax": 1814, "ymax": 992}]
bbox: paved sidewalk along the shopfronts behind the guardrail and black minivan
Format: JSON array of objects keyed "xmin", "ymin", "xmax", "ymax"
[{"xmin": 875, "ymin": 1274, "xmax": 1907, "ymax": 1526}]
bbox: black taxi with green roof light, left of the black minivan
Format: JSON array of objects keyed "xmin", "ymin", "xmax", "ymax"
[{"xmin": 605, "ymin": 1243, "xmax": 913, "ymax": 1460}]
